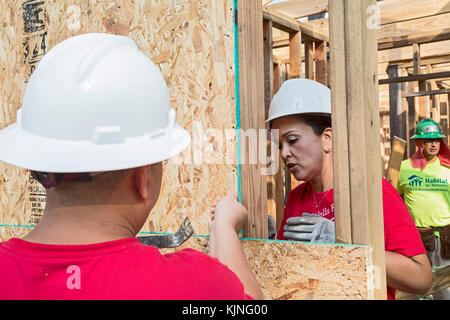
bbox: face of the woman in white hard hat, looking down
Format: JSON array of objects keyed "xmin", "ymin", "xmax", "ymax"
[{"xmin": 272, "ymin": 116, "xmax": 331, "ymax": 181}]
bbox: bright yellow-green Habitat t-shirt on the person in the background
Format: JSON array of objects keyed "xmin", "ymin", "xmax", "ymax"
[{"xmin": 397, "ymin": 158, "xmax": 450, "ymax": 227}]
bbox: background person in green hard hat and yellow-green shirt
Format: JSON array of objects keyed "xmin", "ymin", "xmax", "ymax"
[{"xmin": 397, "ymin": 119, "xmax": 450, "ymax": 300}]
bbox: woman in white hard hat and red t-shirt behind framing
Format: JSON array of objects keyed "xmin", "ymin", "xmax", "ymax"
[{"xmin": 217, "ymin": 79, "xmax": 431, "ymax": 299}]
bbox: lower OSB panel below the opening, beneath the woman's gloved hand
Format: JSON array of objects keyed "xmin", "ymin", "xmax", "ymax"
[{"xmin": 162, "ymin": 236, "xmax": 369, "ymax": 300}]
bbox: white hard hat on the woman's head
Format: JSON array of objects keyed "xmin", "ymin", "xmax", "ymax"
[{"xmin": 266, "ymin": 79, "xmax": 331, "ymax": 123}]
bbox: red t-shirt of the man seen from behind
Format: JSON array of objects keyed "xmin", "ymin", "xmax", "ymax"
[{"xmin": 0, "ymin": 238, "xmax": 251, "ymax": 300}]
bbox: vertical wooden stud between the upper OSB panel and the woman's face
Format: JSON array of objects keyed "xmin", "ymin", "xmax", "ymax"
[{"xmin": 237, "ymin": 0, "xmax": 268, "ymax": 238}]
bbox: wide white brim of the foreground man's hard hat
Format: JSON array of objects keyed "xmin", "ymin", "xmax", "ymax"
[{"xmin": 0, "ymin": 123, "xmax": 191, "ymax": 173}]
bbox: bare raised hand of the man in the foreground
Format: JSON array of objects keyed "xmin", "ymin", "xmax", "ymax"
[{"xmin": 211, "ymin": 192, "xmax": 248, "ymax": 233}]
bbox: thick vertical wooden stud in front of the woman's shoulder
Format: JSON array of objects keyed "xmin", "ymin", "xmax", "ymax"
[{"xmin": 330, "ymin": 0, "xmax": 386, "ymax": 299}]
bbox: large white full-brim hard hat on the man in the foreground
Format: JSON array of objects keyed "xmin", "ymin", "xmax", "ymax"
[{"xmin": 0, "ymin": 33, "xmax": 190, "ymax": 173}]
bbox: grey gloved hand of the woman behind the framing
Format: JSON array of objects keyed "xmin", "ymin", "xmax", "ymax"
[{"xmin": 283, "ymin": 213, "xmax": 335, "ymax": 243}]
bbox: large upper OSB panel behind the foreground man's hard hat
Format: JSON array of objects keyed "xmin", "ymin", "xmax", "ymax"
[{"xmin": 0, "ymin": 0, "xmax": 237, "ymax": 234}]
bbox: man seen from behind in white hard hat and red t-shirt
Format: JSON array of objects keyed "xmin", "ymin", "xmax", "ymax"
[{"xmin": 0, "ymin": 34, "xmax": 262, "ymax": 299}]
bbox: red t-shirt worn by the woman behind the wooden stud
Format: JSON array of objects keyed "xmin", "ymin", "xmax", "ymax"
[{"xmin": 277, "ymin": 179, "xmax": 426, "ymax": 300}]
